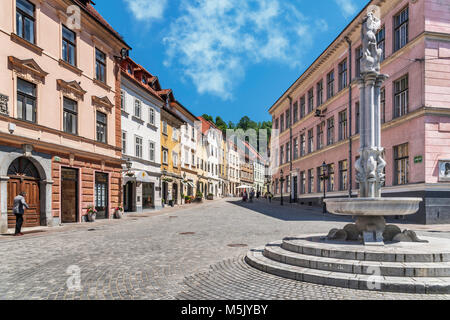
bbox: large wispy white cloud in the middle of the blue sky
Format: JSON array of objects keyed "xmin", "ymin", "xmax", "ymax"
[{"xmin": 164, "ymin": 0, "xmax": 323, "ymax": 99}]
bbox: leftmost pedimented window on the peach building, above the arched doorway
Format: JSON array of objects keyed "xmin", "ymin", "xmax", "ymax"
[{"xmin": 17, "ymin": 78, "xmax": 36, "ymax": 122}]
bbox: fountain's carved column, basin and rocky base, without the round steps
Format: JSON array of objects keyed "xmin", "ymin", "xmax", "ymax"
[{"xmin": 325, "ymin": 13, "xmax": 422, "ymax": 245}]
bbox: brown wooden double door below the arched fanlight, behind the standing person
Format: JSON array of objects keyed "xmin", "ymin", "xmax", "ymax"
[{"xmin": 8, "ymin": 177, "xmax": 41, "ymax": 228}]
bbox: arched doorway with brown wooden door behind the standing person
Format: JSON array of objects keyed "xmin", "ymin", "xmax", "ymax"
[{"xmin": 8, "ymin": 157, "xmax": 41, "ymax": 228}]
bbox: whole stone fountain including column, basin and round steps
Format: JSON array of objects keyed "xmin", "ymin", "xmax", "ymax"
[{"xmin": 245, "ymin": 13, "xmax": 450, "ymax": 293}]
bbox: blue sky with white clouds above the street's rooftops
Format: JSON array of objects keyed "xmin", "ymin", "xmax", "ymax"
[{"xmin": 95, "ymin": 0, "xmax": 368, "ymax": 123}]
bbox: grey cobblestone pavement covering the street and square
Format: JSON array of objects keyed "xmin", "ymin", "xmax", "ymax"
[{"xmin": 0, "ymin": 200, "xmax": 450, "ymax": 299}]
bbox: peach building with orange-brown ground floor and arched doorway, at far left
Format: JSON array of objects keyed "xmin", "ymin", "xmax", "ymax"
[{"xmin": 0, "ymin": 0, "xmax": 129, "ymax": 232}]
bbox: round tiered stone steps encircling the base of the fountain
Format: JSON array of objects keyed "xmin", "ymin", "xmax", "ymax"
[{"xmin": 246, "ymin": 236, "xmax": 450, "ymax": 294}]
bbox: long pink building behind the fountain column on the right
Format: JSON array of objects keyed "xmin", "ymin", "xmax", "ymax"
[{"xmin": 269, "ymin": 0, "xmax": 450, "ymax": 224}]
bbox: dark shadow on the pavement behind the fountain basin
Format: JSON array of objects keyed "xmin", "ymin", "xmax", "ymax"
[{"xmin": 227, "ymin": 199, "xmax": 352, "ymax": 222}]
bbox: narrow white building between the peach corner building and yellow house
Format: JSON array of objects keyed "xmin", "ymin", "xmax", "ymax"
[{"xmin": 121, "ymin": 59, "xmax": 164, "ymax": 212}]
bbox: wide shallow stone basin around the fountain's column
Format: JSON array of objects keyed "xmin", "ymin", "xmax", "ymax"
[{"xmin": 325, "ymin": 198, "xmax": 423, "ymax": 216}]
